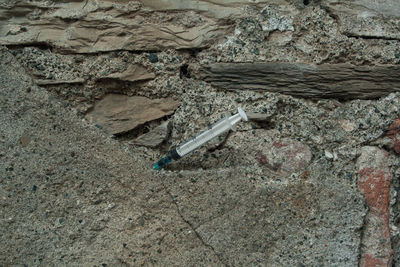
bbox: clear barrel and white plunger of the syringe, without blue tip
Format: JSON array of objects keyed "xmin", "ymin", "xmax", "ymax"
[{"xmin": 176, "ymin": 108, "xmax": 247, "ymax": 157}]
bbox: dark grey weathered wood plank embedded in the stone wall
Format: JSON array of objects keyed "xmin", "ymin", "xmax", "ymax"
[{"xmin": 197, "ymin": 62, "xmax": 400, "ymax": 99}]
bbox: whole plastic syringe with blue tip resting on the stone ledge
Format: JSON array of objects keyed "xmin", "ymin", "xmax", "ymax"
[{"xmin": 153, "ymin": 108, "xmax": 248, "ymax": 170}]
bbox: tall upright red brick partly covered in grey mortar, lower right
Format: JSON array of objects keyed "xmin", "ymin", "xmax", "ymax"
[{"xmin": 357, "ymin": 146, "xmax": 392, "ymax": 267}]
